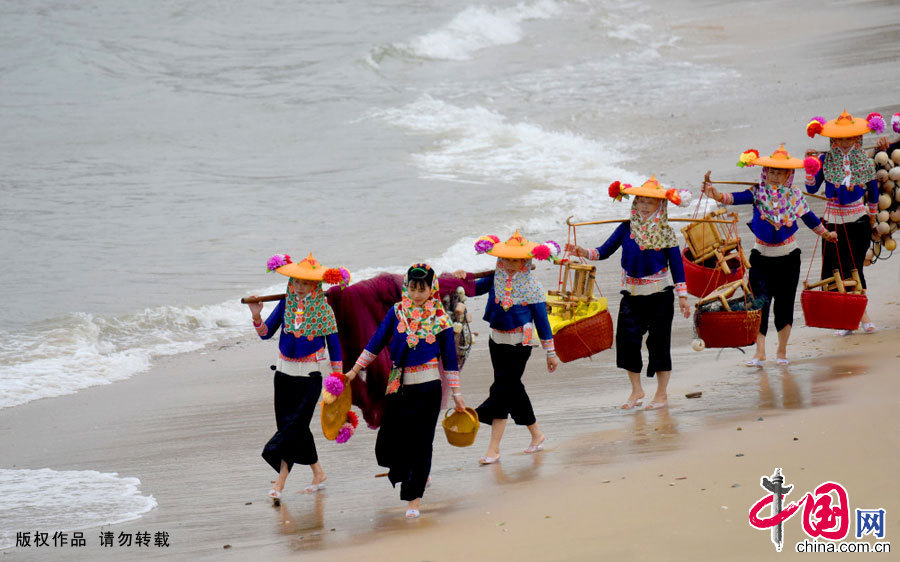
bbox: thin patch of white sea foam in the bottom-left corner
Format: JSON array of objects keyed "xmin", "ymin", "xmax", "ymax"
[{"xmin": 0, "ymin": 468, "xmax": 157, "ymax": 549}]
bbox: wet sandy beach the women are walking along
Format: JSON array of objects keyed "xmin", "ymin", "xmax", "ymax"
[{"xmin": 0, "ymin": 0, "xmax": 900, "ymax": 561}]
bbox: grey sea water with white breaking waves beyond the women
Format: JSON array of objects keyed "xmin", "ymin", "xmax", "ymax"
[{"xmin": 0, "ymin": 0, "xmax": 734, "ymax": 408}]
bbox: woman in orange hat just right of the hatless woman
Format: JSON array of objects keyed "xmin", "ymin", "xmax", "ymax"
[{"xmin": 475, "ymin": 231, "xmax": 559, "ymax": 464}]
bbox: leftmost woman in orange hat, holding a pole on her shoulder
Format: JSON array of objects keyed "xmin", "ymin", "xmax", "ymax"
[{"xmin": 247, "ymin": 254, "xmax": 350, "ymax": 501}]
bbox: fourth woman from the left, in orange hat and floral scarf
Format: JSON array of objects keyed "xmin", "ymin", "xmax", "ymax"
[{"xmin": 566, "ymin": 176, "xmax": 691, "ymax": 410}]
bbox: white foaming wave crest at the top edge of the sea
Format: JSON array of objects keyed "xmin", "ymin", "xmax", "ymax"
[{"xmin": 376, "ymin": 0, "xmax": 561, "ymax": 61}]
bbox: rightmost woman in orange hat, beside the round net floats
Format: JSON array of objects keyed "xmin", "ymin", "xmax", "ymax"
[{"xmin": 806, "ymin": 110, "xmax": 884, "ymax": 336}]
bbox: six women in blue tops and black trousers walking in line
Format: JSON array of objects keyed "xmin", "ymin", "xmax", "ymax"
[{"xmin": 243, "ymin": 108, "xmax": 883, "ymax": 518}]
